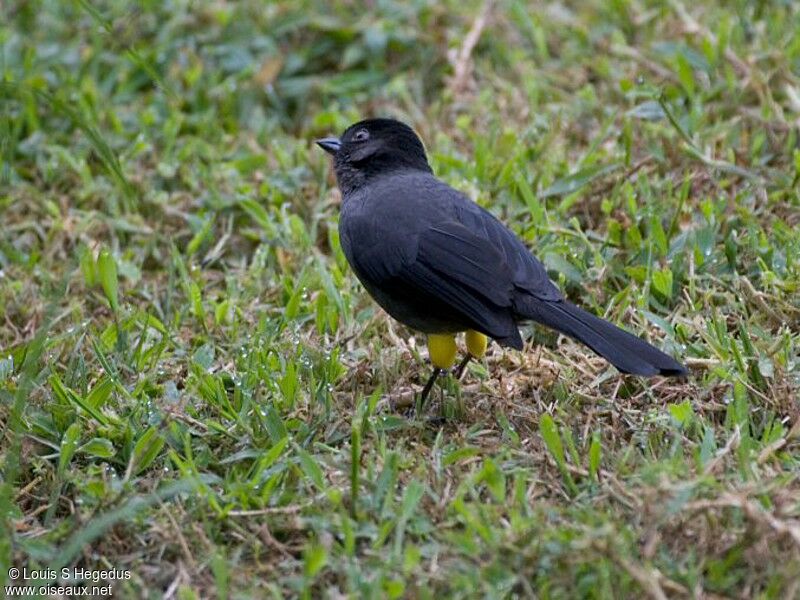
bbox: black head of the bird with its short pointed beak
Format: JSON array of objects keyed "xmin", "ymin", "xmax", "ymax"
[{"xmin": 317, "ymin": 119, "xmax": 431, "ymax": 194}]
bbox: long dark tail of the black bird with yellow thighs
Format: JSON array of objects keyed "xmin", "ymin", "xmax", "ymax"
[{"xmin": 515, "ymin": 298, "xmax": 686, "ymax": 376}]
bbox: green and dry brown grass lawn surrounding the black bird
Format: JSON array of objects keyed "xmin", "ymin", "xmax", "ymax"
[{"xmin": 0, "ymin": 0, "xmax": 800, "ymax": 599}]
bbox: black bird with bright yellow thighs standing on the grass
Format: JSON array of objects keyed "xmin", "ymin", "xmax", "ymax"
[{"xmin": 316, "ymin": 118, "xmax": 687, "ymax": 410}]
